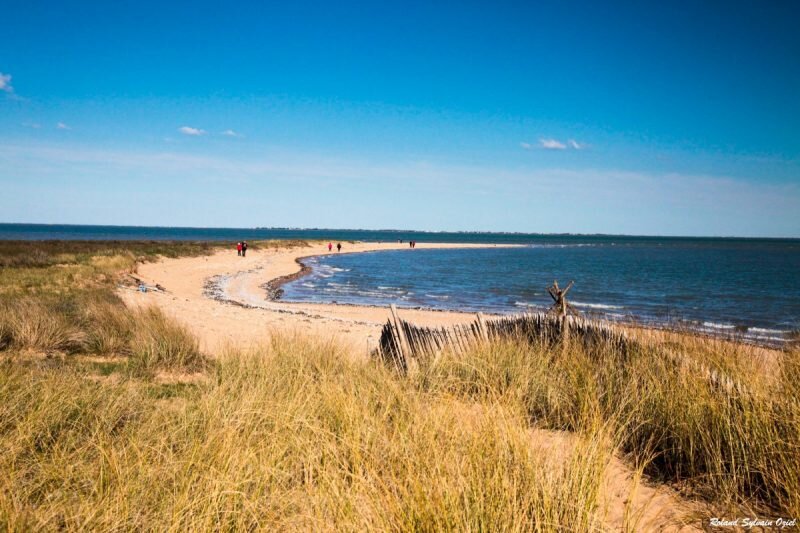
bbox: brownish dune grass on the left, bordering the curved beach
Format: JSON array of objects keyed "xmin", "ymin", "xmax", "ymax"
[{"xmin": 0, "ymin": 241, "xmax": 306, "ymax": 371}]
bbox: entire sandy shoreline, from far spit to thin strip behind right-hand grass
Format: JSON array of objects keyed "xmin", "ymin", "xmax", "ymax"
[{"xmin": 120, "ymin": 242, "xmax": 786, "ymax": 349}]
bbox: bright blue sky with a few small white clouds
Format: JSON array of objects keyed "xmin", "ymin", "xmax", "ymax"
[{"xmin": 0, "ymin": 1, "xmax": 800, "ymax": 237}]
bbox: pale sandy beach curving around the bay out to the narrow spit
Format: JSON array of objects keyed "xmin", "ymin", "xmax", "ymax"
[{"xmin": 119, "ymin": 242, "xmax": 520, "ymax": 357}]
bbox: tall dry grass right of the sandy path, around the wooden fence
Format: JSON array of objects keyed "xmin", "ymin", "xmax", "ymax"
[{"xmin": 414, "ymin": 339, "xmax": 800, "ymax": 516}]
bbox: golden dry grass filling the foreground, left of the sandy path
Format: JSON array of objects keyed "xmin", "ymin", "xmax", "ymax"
[{"xmin": 0, "ymin": 339, "xmax": 611, "ymax": 531}]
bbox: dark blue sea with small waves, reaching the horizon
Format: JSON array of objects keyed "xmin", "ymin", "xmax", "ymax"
[{"xmin": 0, "ymin": 224, "xmax": 800, "ymax": 341}]
